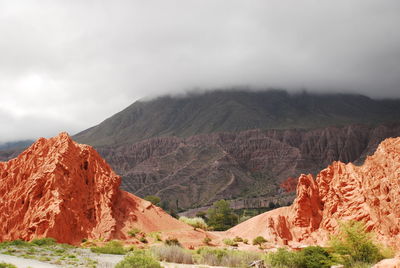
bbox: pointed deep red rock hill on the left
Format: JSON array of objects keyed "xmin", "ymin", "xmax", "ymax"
[{"xmin": 0, "ymin": 133, "xmax": 199, "ymax": 244}]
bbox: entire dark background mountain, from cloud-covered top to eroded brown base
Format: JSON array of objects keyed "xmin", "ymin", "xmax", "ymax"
[{"xmin": 70, "ymin": 90, "xmax": 400, "ymax": 211}]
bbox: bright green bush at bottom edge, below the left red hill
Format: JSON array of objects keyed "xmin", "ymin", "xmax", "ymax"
[{"xmin": 115, "ymin": 250, "xmax": 162, "ymax": 268}]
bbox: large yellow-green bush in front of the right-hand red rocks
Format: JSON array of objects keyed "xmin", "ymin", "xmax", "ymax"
[{"xmin": 330, "ymin": 221, "xmax": 390, "ymax": 267}]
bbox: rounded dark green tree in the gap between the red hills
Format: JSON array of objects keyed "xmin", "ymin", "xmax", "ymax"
[{"xmin": 207, "ymin": 200, "xmax": 238, "ymax": 231}]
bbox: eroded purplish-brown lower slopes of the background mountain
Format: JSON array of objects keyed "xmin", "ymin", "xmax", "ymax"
[{"xmin": 97, "ymin": 124, "xmax": 400, "ymax": 210}]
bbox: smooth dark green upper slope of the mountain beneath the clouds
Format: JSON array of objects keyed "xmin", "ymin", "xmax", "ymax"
[{"xmin": 74, "ymin": 90, "xmax": 400, "ymax": 146}]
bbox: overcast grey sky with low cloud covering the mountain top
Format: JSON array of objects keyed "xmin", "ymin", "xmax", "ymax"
[{"xmin": 0, "ymin": 0, "xmax": 400, "ymax": 143}]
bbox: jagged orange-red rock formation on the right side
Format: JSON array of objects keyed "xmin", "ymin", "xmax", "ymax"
[{"xmin": 227, "ymin": 138, "xmax": 400, "ymax": 249}]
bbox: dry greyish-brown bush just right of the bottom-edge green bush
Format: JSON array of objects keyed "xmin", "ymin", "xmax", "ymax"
[{"xmin": 151, "ymin": 245, "xmax": 193, "ymax": 264}]
